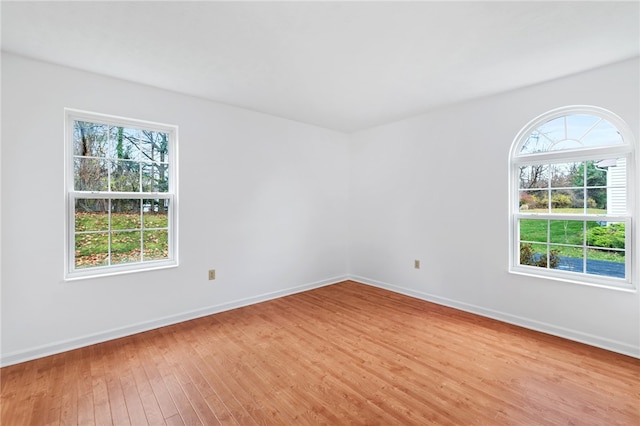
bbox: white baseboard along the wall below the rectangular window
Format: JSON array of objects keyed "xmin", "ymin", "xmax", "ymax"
[{"xmin": 0, "ymin": 275, "xmax": 349, "ymax": 367}]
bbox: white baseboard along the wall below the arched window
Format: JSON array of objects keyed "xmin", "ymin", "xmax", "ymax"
[{"xmin": 349, "ymin": 275, "xmax": 640, "ymax": 358}]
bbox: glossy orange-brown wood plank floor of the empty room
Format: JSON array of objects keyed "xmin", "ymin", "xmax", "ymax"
[{"xmin": 0, "ymin": 281, "xmax": 640, "ymax": 426}]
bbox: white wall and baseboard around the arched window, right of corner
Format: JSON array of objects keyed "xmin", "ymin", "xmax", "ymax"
[{"xmin": 349, "ymin": 59, "xmax": 640, "ymax": 356}]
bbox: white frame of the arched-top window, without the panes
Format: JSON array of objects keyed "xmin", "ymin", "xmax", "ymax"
[{"xmin": 509, "ymin": 106, "xmax": 639, "ymax": 290}]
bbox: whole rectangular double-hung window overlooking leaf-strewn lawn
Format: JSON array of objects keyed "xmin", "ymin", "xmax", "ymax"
[{"xmin": 65, "ymin": 110, "xmax": 177, "ymax": 279}]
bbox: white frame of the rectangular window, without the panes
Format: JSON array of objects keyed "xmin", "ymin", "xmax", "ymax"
[{"xmin": 64, "ymin": 108, "xmax": 178, "ymax": 280}]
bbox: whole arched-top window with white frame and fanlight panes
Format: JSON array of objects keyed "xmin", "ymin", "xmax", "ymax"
[{"xmin": 510, "ymin": 107, "xmax": 638, "ymax": 288}]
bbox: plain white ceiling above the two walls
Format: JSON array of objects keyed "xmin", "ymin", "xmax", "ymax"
[{"xmin": 1, "ymin": 1, "xmax": 640, "ymax": 132}]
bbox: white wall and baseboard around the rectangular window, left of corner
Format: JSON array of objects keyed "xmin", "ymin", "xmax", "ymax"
[{"xmin": 1, "ymin": 54, "xmax": 348, "ymax": 365}]
